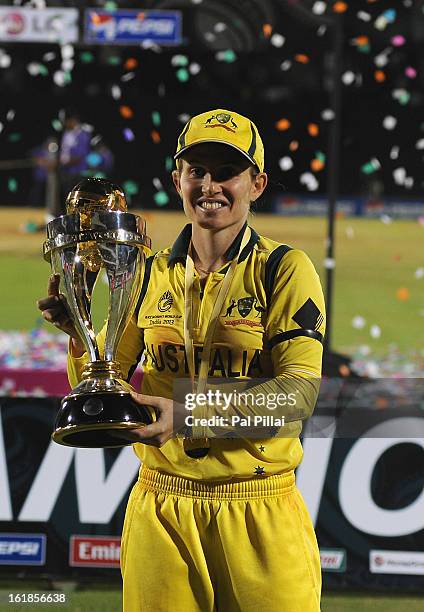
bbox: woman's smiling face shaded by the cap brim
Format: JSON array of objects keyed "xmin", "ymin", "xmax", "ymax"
[{"xmin": 173, "ymin": 143, "xmax": 267, "ymax": 230}]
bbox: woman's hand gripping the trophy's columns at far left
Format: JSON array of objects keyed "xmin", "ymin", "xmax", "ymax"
[{"xmin": 37, "ymin": 274, "xmax": 85, "ymax": 354}]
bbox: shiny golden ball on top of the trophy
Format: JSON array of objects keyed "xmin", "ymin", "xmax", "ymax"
[{"xmin": 66, "ymin": 177, "xmax": 128, "ymax": 215}]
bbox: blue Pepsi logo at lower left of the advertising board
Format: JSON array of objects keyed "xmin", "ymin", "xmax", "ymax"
[{"xmin": 0, "ymin": 533, "xmax": 46, "ymax": 565}]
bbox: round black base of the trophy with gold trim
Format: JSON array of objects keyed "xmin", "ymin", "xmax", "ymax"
[{"xmin": 52, "ymin": 392, "xmax": 156, "ymax": 448}]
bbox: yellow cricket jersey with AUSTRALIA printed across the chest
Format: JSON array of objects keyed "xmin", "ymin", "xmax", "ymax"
[{"xmin": 68, "ymin": 225, "xmax": 325, "ymax": 481}]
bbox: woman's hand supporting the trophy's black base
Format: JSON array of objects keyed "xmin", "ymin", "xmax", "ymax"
[{"xmin": 116, "ymin": 391, "xmax": 186, "ymax": 448}]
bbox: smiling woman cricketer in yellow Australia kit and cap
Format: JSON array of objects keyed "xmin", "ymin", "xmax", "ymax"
[{"xmin": 39, "ymin": 109, "xmax": 325, "ymax": 612}]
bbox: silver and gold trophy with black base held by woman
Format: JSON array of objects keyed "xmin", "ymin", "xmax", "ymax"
[{"xmin": 43, "ymin": 178, "xmax": 155, "ymax": 448}]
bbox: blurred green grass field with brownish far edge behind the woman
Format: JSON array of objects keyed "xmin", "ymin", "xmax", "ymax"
[{"xmin": 0, "ymin": 208, "xmax": 424, "ymax": 355}]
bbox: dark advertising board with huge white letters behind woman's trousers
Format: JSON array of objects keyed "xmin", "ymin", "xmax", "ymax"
[{"xmin": 0, "ymin": 392, "xmax": 424, "ymax": 590}]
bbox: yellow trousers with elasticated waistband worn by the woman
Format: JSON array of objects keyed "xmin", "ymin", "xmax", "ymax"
[{"xmin": 121, "ymin": 468, "xmax": 321, "ymax": 612}]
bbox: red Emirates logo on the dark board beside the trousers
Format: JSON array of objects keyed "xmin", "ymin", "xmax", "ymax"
[{"xmin": 69, "ymin": 535, "xmax": 121, "ymax": 568}]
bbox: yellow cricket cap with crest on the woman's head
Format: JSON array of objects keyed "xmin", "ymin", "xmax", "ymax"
[{"xmin": 174, "ymin": 108, "xmax": 265, "ymax": 172}]
